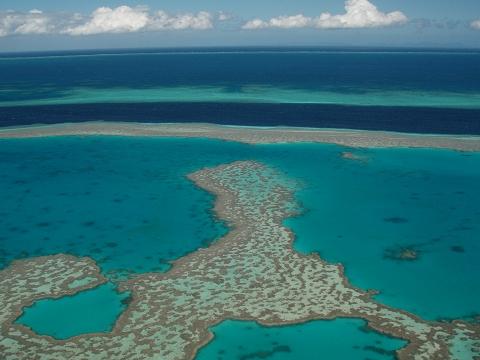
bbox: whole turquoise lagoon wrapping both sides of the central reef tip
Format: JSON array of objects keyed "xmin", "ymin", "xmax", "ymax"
[{"xmin": 0, "ymin": 137, "xmax": 480, "ymax": 333}]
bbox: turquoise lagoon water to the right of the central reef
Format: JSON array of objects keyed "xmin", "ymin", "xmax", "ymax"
[{"xmin": 278, "ymin": 145, "xmax": 480, "ymax": 319}]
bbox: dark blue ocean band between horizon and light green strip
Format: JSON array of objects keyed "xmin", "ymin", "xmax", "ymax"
[{"xmin": 0, "ymin": 48, "xmax": 480, "ymax": 93}]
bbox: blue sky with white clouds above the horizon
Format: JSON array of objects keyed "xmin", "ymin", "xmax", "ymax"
[{"xmin": 0, "ymin": 0, "xmax": 480, "ymax": 52}]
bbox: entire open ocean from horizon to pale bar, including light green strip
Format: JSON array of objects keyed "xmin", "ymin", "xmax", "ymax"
[{"xmin": 0, "ymin": 48, "xmax": 480, "ymax": 134}]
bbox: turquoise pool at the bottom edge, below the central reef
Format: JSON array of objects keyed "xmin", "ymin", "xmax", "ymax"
[{"xmin": 196, "ymin": 319, "xmax": 405, "ymax": 360}]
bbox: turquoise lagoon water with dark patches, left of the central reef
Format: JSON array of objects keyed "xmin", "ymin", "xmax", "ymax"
[{"xmin": 0, "ymin": 138, "xmax": 237, "ymax": 276}]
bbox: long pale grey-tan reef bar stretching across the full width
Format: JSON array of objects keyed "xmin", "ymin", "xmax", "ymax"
[{"xmin": 0, "ymin": 122, "xmax": 480, "ymax": 151}]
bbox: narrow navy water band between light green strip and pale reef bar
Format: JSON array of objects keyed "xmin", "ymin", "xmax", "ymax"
[{"xmin": 0, "ymin": 103, "xmax": 480, "ymax": 135}]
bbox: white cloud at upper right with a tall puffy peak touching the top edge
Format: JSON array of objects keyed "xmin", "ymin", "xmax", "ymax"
[{"xmin": 242, "ymin": 0, "xmax": 408, "ymax": 30}]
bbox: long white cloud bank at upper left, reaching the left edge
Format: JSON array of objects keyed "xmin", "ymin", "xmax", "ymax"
[{"xmin": 0, "ymin": 5, "xmax": 214, "ymax": 37}]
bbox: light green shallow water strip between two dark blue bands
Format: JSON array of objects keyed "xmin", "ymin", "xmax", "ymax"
[{"xmin": 0, "ymin": 85, "xmax": 480, "ymax": 109}]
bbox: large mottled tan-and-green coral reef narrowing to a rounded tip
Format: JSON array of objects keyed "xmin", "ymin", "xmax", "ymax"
[{"xmin": 0, "ymin": 161, "xmax": 480, "ymax": 360}]
